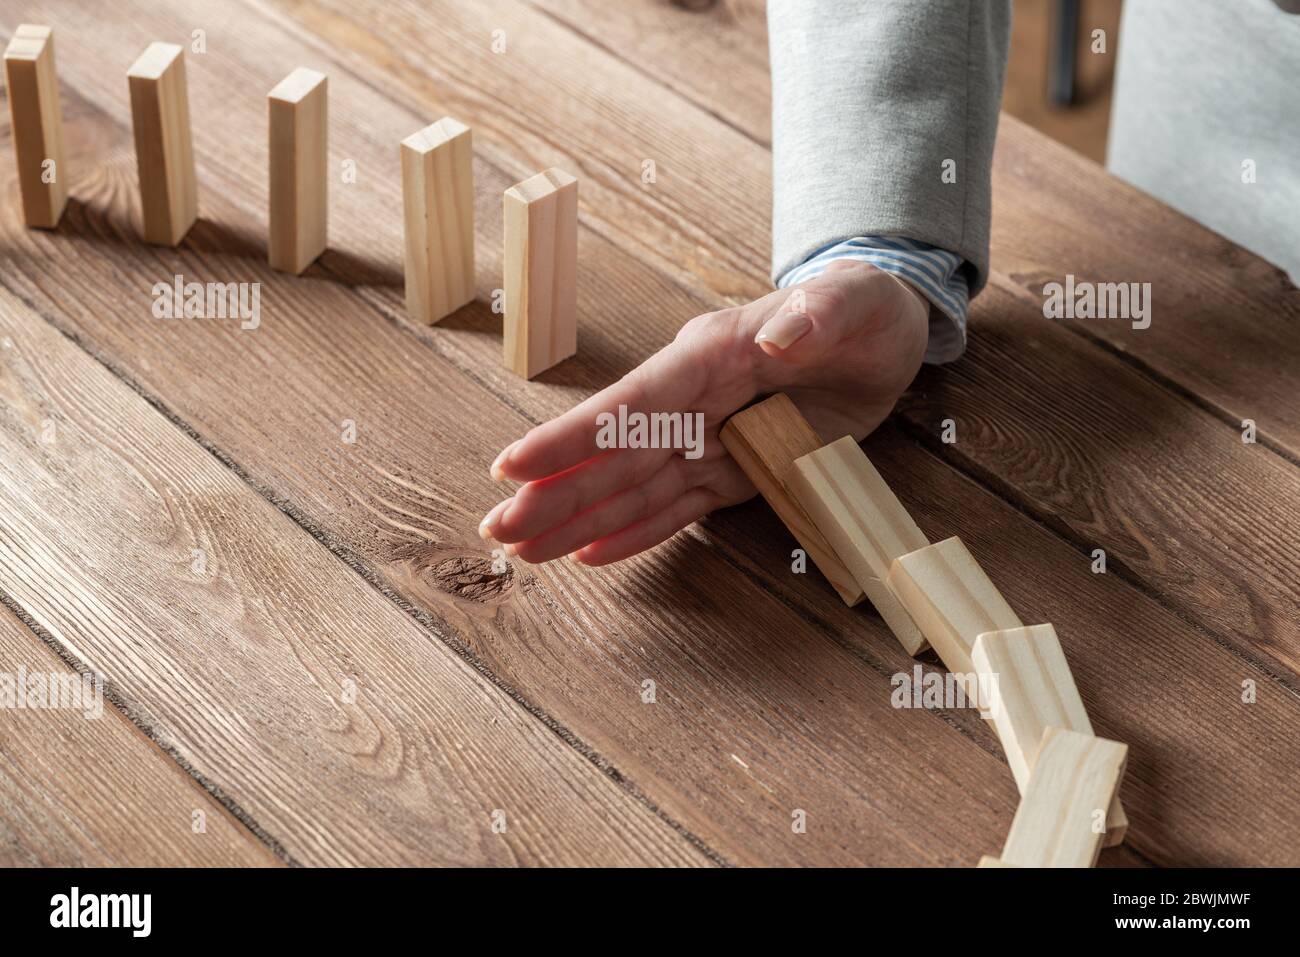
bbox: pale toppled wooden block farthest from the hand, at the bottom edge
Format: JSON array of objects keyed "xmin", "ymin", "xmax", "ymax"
[{"xmin": 1002, "ymin": 728, "xmax": 1128, "ymax": 867}]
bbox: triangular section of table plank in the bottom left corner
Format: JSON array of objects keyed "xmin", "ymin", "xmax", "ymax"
[{"xmin": 0, "ymin": 606, "xmax": 277, "ymax": 867}]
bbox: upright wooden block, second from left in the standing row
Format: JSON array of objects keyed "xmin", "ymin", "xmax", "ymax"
[{"xmin": 126, "ymin": 43, "xmax": 199, "ymax": 246}]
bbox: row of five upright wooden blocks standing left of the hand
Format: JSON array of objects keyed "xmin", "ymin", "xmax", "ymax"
[{"xmin": 4, "ymin": 23, "xmax": 577, "ymax": 378}]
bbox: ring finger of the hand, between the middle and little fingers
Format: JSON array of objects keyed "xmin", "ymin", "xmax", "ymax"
[{"xmin": 506, "ymin": 456, "xmax": 690, "ymax": 564}]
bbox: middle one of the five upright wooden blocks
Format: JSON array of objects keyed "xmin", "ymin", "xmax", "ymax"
[{"xmin": 267, "ymin": 66, "xmax": 329, "ymax": 276}]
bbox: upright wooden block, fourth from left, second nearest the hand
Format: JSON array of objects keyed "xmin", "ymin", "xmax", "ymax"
[{"xmin": 402, "ymin": 117, "xmax": 475, "ymax": 325}]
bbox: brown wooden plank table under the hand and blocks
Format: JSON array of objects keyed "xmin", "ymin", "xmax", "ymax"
[{"xmin": 0, "ymin": 0, "xmax": 1300, "ymax": 866}]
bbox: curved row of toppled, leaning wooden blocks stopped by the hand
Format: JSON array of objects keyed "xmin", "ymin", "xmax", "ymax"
[{"xmin": 722, "ymin": 394, "xmax": 1128, "ymax": 867}]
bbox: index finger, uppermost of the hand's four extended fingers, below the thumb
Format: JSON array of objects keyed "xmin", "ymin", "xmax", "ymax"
[{"xmin": 491, "ymin": 345, "xmax": 701, "ymax": 482}]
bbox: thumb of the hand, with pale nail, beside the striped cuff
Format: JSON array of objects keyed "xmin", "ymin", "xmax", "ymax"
[{"xmin": 754, "ymin": 260, "xmax": 928, "ymax": 364}]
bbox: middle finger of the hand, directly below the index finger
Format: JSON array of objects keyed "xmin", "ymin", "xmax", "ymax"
[{"xmin": 480, "ymin": 449, "xmax": 673, "ymax": 544}]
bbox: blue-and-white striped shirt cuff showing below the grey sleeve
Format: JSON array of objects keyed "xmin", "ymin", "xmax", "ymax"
[{"xmin": 776, "ymin": 235, "xmax": 970, "ymax": 364}]
